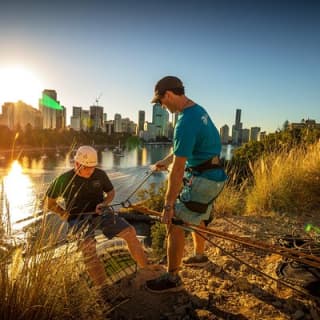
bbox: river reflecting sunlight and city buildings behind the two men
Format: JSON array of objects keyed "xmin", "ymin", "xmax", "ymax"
[{"xmin": 0, "ymin": 145, "xmax": 232, "ymax": 231}]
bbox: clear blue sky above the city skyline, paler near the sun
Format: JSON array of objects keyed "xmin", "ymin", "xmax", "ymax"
[{"xmin": 0, "ymin": 0, "xmax": 320, "ymax": 132}]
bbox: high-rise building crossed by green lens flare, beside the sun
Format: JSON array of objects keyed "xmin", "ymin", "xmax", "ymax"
[{"xmin": 39, "ymin": 89, "xmax": 66, "ymax": 129}]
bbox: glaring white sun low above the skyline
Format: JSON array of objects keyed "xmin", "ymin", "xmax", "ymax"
[{"xmin": 0, "ymin": 66, "xmax": 43, "ymax": 107}]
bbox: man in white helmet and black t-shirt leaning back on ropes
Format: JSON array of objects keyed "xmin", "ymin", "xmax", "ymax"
[{"xmin": 45, "ymin": 146, "xmax": 147, "ymax": 300}]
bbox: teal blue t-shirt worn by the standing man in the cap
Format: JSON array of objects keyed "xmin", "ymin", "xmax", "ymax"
[{"xmin": 173, "ymin": 104, "xmax": 227, "ymax": 181}]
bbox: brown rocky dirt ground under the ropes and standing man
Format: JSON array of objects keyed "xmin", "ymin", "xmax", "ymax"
[{"xmin": 106, "ymin": 211, "xmax": 320, "ymax": 320}]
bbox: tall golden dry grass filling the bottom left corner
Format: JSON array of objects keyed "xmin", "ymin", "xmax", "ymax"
[{"xmin": 0, "ymin": 220, "xmax": 102, "ymax": 320}]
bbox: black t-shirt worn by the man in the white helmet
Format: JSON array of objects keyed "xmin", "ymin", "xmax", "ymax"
[{"xmin": 46, "ymin": 168, "xmax": 113, "ymax": 219}]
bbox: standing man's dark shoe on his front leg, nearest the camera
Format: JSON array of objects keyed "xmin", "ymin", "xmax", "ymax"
[{"xmin": 146, "ymin": 272, "xmax": 183, "ymax": 293}]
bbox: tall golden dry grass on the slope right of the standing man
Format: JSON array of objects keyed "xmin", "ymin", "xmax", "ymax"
[{"xmin": 214, "ymin": 142, "xmax": 320, "ymax": 216}]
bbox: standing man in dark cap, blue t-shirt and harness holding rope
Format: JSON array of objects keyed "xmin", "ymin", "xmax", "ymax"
[{"xmin": 146, "ymin": 76, "xmax": 227, "ymax": 293}]
